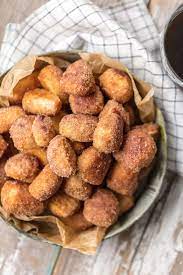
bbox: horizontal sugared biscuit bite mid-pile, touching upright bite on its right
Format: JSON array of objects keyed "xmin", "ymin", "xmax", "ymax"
[{"xmin": 59, "ymin": 114, "xmax": 98, "ymax": 142}]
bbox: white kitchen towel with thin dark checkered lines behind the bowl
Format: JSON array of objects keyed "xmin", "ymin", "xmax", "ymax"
[{"xmin": 0, "ymin": 0, "xmax": 183, "ymax": 175}]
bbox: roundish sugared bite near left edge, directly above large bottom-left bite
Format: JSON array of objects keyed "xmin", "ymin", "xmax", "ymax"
[{"xmin": 5, "ymin": 153, "xmax": 39, "ymax": 183}]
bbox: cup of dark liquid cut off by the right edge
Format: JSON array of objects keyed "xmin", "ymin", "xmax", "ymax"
[{"xmin": 160, "ymin": 5, "xmax": 183, "ymax": 87}]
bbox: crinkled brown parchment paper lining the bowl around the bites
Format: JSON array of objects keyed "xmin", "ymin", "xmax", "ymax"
[{"xmin": 0, "ymin": 52, "xmax": 155, "ymax": 254}]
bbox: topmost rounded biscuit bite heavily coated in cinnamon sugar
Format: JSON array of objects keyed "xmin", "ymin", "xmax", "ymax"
[{"xmin": 61, "ymin": 59, "xmax": 95, "ymax": 96}]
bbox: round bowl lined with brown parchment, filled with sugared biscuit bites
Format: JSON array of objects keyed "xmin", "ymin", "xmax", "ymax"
[{"xmin": 0, "ymin": 52, "xmax": 167, "ymax": 254}]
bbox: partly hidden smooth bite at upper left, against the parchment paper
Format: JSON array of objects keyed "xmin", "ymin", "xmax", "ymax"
[{"xmin": 9, "ymin": 71, "xmax": 41, "ymax": 104}]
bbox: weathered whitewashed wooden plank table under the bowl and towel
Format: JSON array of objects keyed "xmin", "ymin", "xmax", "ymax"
[{"xmin": 0, "ymin": 0, "xmax": 183, "ymax": 275}]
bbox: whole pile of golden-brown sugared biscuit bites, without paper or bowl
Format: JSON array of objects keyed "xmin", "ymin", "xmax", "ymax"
[{"xmin": 0, "ymin": 59, "xmax": 158, "ymax": 230}]
